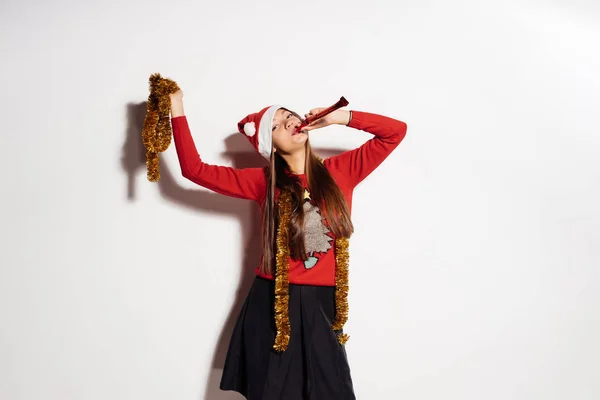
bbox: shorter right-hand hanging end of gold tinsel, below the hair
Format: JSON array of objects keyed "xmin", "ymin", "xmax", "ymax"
[{"xmin": 332, "ymin": 237, "xmax": 350, "ymax": 344}]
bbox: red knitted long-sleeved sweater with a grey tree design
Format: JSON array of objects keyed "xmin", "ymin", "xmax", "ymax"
[{"xmin": 171, "ymin": 111, "xmax": 406, "ymax": 286}]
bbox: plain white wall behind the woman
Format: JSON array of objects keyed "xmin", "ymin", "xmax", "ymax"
[{"xmin": 0, "ymin": 0, "xmax": 600, "ymax": 400}]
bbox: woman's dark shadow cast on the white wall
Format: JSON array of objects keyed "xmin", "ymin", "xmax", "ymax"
[{"xmin": 121, "ymin": 102, "xmax": 344, "ymax": 400}]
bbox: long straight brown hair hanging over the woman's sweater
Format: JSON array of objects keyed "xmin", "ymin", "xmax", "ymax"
[{"xmin": 260, "ymin": 140, "xmax": 354, "ymax": 275}]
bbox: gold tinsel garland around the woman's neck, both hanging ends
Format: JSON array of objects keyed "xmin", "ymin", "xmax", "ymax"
[{"xmin": 273, "ymin": 191, "xmax": 350, "ymax": 352}]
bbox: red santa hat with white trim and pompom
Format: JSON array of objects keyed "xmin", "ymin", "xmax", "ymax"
[{"xmin": 238, "ymin": 104, "xmax": 282, "ymax": 160}]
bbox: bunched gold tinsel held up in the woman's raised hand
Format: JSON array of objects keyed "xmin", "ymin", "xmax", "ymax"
[{"xmin": 142, "ymin": 73, "xmax": 179, "ymax": 182}]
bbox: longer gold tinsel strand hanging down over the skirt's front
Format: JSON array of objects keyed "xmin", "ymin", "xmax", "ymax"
[{"xmin": 273, "ymin": 191, "xmax": 292, "ymax": 352}]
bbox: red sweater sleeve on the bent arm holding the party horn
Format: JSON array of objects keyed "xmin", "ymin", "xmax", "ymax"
[{"xmin": 326, "ymin": 111, "xmax": 407, "ymax": 188}]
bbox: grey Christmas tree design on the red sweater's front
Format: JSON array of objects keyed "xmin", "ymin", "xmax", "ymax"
[{"xmin": 303, "ymin": 189, "xmax": 334, "ymax": 269}]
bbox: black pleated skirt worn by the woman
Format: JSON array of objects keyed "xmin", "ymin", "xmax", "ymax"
[{"xmin": 220, "ymin": 276, "xmax": 356, "ymax": 400}]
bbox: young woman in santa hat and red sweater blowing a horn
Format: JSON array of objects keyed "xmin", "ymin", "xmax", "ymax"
[{"xmin": 171, "ymin": 91, "xmax": 406, "ymax": 400}]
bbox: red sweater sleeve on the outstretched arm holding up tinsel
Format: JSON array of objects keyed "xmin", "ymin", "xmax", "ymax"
[{"xmin": 171, "ymin": 116, "xmax": 266, "ymax": 202}]
